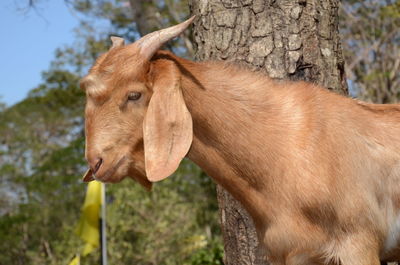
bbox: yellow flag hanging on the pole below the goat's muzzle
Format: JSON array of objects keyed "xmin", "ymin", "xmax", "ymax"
[{"xmin": 76, "ymin": 181, "xmax": 102, "ymax": 256}]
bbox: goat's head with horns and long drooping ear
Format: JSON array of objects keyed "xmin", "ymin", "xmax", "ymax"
[{"xmin": 81, "ymin": 17, "xmax": 194, "ymax": 188}]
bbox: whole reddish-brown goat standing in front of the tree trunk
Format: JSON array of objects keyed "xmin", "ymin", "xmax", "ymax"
[{"xmin": 81, "ymin": 19, "xmax": 400, "ymax": 265}]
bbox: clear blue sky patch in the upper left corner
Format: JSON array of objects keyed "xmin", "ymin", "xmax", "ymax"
[{"xmin": 0, "ymin": 0, "xmax": 79, "ymax": 105}]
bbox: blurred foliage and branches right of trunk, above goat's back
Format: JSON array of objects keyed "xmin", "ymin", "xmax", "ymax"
[{"xmin": 340, "ymin": 0, "xmax": 400, "ymax": 103}]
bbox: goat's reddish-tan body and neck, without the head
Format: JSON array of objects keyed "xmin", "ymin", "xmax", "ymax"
[{"xmin": 160, "ymin": 54, "xmax": 400, "ymax": 264}]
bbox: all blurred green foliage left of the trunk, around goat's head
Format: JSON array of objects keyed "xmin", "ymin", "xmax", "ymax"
[{"xmin": 0, "ymin": 0, "xmax": 222, "ymax": 265}]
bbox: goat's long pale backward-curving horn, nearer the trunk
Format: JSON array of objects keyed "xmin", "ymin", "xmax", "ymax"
[{"xmin": 134, "ymin": 16, "xmax": 196, "ymax": 60}]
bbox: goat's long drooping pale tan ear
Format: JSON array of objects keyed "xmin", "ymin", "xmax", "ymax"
[{"xmin": 143, "ymin": 61, "xmax": 193, "ymax": 182}]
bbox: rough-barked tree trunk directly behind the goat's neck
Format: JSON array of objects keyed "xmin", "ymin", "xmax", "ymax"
[{"xmin": 189, "ymin": 0, "xmax": 347, "ymax": 265}]
